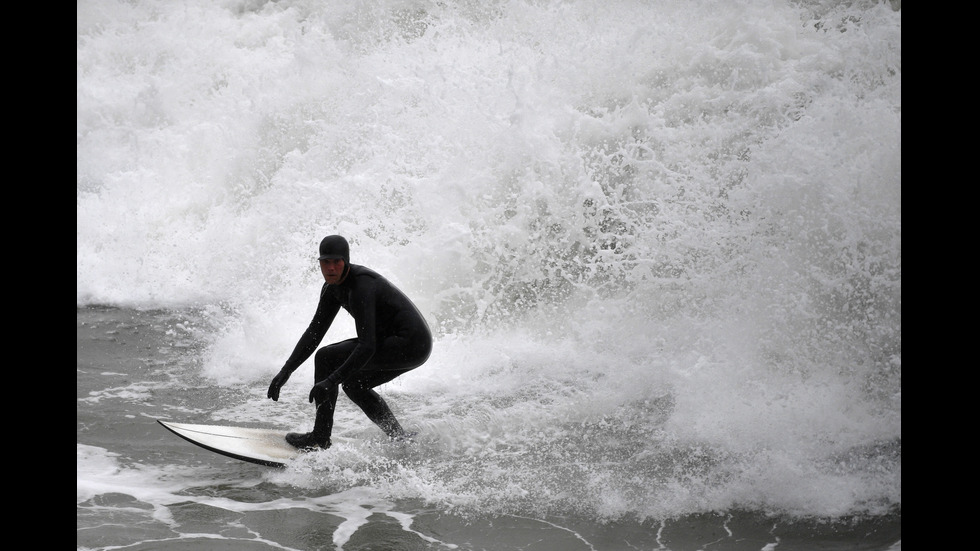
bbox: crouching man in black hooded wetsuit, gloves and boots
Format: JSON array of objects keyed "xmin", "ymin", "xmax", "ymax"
[{"xmin": 268, "ymin": 235, "xmax": 432, "ymax": 450}]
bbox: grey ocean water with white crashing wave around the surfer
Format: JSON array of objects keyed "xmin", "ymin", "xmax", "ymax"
[{"xmin": 76, "ymin": 0, "xmax": 902, "ymax": 551}]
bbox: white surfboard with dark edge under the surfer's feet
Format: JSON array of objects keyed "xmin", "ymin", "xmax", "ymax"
[{"xmin": 157, "ymin": 419, "xmax": 302, "ymax": 467}]
